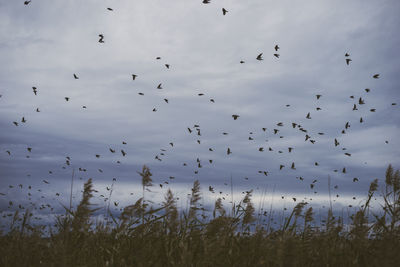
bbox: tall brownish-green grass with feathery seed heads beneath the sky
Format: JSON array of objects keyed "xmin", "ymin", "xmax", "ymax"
[{"xmin": 0, "ymin": 165, "xmax": 400, "ymax": 266}]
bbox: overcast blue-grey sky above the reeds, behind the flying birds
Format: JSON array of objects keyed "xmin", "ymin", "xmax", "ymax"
[{"xmin": 0, "ymin": 0, "xmax": 400, "ymax": 226}]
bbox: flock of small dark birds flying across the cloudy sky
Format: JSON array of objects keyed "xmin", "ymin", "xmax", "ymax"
[{"xmin": 0, "ymin": 0, "xmax": 396, "ymax": 224}]
